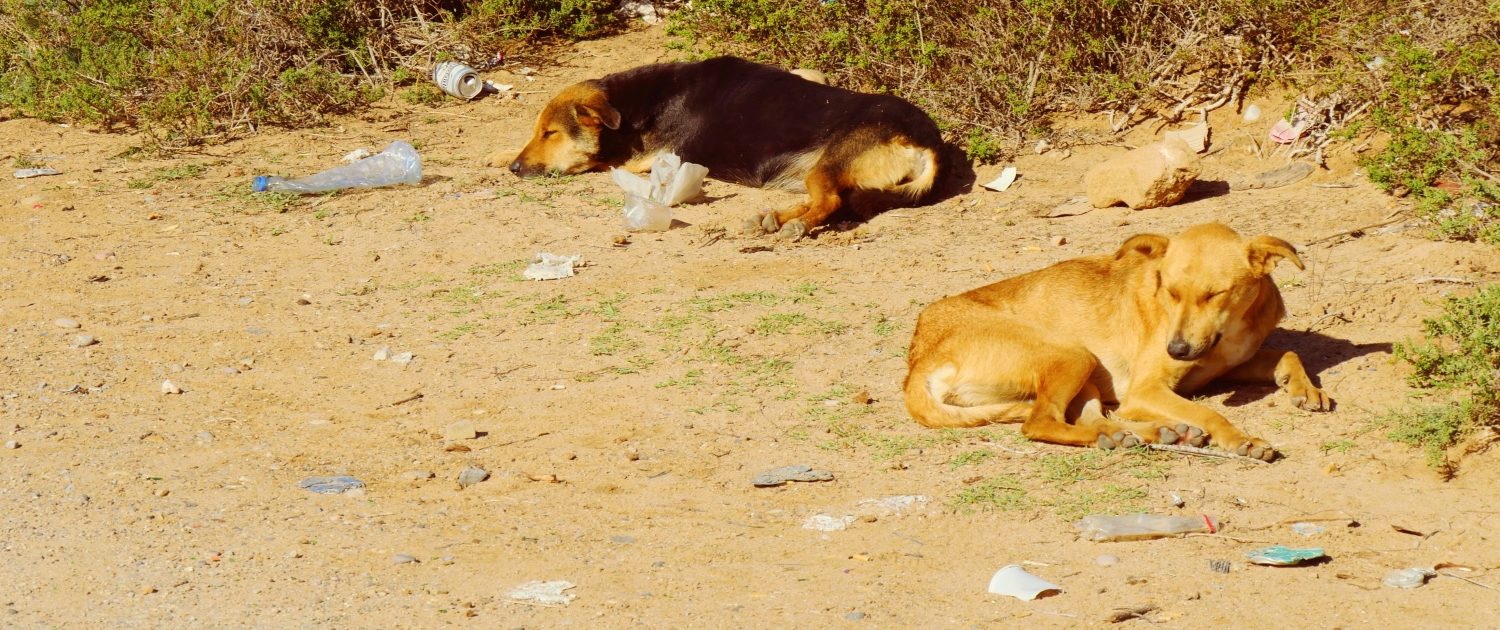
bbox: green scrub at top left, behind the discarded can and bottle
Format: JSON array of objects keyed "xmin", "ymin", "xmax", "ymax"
[{"xmin": 0, "ymin": 0, "xmax": 615, "ymax": 144}]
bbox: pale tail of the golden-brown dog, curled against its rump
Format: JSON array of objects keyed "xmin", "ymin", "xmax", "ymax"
[{"xmin": 906, "ymin": 365, "xmax": 1032, "ymax": 429}]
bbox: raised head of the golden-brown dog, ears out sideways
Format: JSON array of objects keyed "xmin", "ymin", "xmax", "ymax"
[{"xmin": 1116, "ymin": 224, "xmax": 1305, "ymax": 362}]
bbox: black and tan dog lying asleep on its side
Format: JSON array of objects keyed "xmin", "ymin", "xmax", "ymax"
[{"xmin": 510, "ymin": 57, "xmax": 950, "ymax": 239}]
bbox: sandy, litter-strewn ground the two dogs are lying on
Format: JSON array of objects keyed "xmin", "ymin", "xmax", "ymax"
[{"xmin": 0, "ymin": 32, "xmax": 1500, "ymax": 627}]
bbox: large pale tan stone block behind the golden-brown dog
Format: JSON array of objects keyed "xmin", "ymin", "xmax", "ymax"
[{"xmin": 1083, "ymin": 140, "xmax": 1200, "ymax": 210}]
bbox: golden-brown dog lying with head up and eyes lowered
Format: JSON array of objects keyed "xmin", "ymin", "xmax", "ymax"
[{"xmin": 906, "ymin": 224, "xmax": 1332, "ymax": 462}]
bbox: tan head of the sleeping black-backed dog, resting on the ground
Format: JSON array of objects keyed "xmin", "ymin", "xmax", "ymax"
[{"xmin": 510, "ymin": 81, "xmax": 620, "ymax": 177}]
